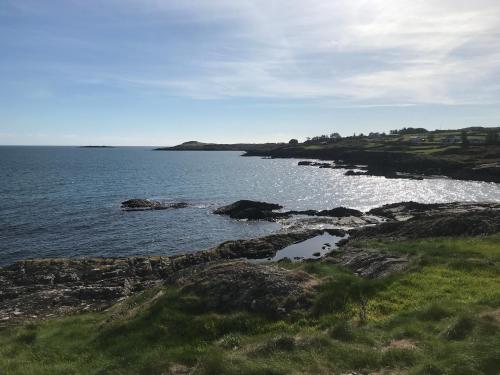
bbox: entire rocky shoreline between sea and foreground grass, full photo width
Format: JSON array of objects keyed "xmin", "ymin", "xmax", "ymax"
[{"xmin": 0, "ymin": 201, "xmax": 500, "ymax": 325}]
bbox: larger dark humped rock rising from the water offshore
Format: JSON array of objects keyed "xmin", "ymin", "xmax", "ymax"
[{"xmin": 214, "ymin": 200, "xmax": 283, "ymax": 220}]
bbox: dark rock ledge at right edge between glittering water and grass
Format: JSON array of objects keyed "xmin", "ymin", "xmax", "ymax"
[{"xmin": 350, "ymin": 209, "xmax": 500, "ymax": 238}]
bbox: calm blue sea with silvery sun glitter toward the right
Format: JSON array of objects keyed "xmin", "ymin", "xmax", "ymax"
[{"xmin": 0, "ymin": 147, "xmax": 500, "ymax": 265}]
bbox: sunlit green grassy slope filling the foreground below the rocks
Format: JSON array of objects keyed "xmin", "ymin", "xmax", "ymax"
[{"xmin": 0, "ymin": 234, "xmax": 500, "ymax": 374}]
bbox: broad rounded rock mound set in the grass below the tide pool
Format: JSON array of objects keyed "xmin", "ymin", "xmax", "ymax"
[{"xmin": 170, "ymin": 261, "xmax": 317, "ymax": 316}]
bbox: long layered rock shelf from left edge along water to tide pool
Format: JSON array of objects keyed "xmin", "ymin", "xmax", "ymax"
[{"xmin": 0, "ymin": 231, "xmax": 338, "ymax": 324}]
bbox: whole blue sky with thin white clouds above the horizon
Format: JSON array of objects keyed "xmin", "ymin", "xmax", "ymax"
[{"xmin": 0, "ymin": 0, "xmax": 500, "ymax": 146}]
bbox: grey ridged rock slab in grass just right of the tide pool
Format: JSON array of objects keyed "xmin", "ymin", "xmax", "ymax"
[{"xmin": 323, "ymin": 246, "xmax": 409, "ymax": 279}]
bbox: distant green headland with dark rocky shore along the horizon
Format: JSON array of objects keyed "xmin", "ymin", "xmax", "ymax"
[{"xmin": 159, "ymin": 127, "xmax": 500, "ymax": 183}]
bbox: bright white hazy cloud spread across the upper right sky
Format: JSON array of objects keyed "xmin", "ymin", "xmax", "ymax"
[{"xmin": 111, "ymin": 0, "xmax": 500, "ymax": 105}]
